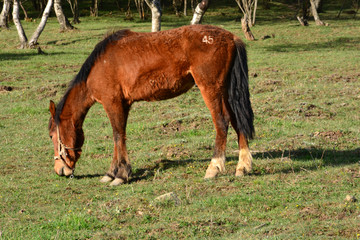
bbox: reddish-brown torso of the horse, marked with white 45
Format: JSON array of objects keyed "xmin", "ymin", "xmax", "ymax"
[{"xmin": 88, "ymin": 25, "xmax": 239, "ymax": 102}]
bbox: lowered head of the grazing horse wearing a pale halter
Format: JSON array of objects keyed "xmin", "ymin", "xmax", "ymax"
[{"xmin": 49, "ymin": 101, "xmax": 84, "ymax": 176}]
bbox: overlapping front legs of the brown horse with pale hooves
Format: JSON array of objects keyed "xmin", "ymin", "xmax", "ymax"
[{"xmin": 100, "ymin": 102, "xmax": 131, "ymax": 186}]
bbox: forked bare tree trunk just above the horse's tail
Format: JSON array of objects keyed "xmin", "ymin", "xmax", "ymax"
[{"xmin": 235, "ymin": 0, "xmax": 258, "ymax": 41}]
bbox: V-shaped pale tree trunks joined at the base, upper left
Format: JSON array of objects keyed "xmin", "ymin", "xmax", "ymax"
[{"xmin": 13, "ymin": 0, "xmax": 53, "ymax": 48}]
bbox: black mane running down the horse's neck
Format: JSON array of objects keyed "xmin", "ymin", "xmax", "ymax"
[{"xmin": 55, "ymin": 29, "xmax": 131, "ymax": 124}]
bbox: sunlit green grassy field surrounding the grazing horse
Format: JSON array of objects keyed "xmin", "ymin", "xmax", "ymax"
[{"xmin": 0, "ymin": 1, "xmax": 360, "ymax": 239}]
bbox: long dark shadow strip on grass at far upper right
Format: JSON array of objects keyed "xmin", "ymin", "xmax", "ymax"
[{"xmin": 266, "ymin": 37, "xmax": 360, "ymax": 52}]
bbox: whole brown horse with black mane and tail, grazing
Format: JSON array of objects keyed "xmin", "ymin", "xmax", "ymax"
[{"xmin": 49, "ymin": 25, "xmax": 254, "ymax": 185}]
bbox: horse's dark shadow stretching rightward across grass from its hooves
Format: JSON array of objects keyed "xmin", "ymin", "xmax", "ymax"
[{"xmin": 130, "ymin": 148, "xmax": 360, "ymax": 183}]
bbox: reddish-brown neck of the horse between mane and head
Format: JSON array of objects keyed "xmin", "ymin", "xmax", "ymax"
[{"xmin": 61, "ymin": 82, "xmax": 94, "ymax": 128}]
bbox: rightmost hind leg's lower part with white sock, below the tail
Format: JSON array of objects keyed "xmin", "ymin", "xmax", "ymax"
[{"xmin": 235, "ymin": 133, "xmax": 252, "ymax": 177}]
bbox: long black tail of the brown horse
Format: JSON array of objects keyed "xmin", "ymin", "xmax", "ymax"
[{"xmin": 228, "ymin": 39, "xmax": 255, "ymax": 139}]
